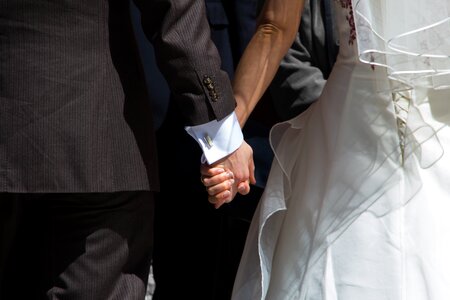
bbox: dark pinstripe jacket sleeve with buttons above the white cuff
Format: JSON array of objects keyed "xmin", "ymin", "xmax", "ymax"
[{"xmin": 135, "ymin": 0, "xmax": 236, "ymax": 126}]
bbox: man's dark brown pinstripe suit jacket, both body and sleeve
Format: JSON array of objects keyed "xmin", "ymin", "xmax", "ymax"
[{"xmin": 0, "ymin": 0, "xmax": 235, "ymax": 192}]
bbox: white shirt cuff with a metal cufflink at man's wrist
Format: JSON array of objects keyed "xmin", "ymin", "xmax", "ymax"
[{"xmin": 185, "ymin": 112, "xmax": 244, "ymax": 164}]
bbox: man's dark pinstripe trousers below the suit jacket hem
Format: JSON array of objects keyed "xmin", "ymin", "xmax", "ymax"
[{"xmin": 0, "ymin": 191, "xmax": 154, "ymax": 300}]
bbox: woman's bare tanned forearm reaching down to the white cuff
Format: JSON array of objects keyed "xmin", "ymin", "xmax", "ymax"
[{"xmin": 233, "ymin": 0, "xmax": 304, "ymax": 127}]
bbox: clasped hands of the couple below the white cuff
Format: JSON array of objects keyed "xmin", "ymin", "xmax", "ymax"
[{"xmin": 200, "ymin": 141, "xmax": 256, "ymax": 208}]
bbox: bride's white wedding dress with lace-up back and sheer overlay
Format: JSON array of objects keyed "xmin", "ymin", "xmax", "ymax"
[{"xmin": 233, "ymin": 0, "xmax": 450, "ymax": 300}]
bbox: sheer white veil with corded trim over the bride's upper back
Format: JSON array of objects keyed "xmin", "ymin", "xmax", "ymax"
[{"xmin": 352, "ymin": 0, "xmax": 450, "ymax": 89}]
